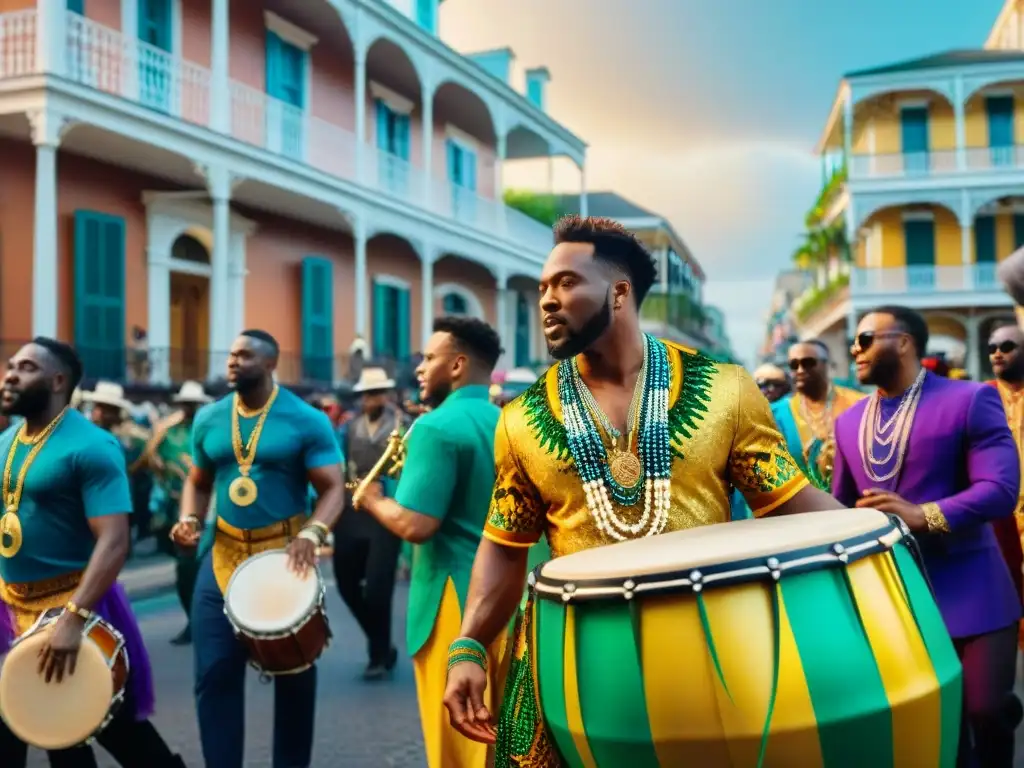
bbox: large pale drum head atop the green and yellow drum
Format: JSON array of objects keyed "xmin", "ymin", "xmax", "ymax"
[{"xmin": 541, "ymin": 509, "xmax": 892, "ymax": 585}]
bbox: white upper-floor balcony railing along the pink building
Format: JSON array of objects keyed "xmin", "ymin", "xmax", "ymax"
[{"xmin": 0, "ymin": 9, "xmax": 551, "ymax": 252}]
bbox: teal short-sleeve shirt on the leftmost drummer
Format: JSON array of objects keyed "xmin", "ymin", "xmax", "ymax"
[{"xmin": 0, "ymin": 410, "xmax": 132, "ymax": 584}]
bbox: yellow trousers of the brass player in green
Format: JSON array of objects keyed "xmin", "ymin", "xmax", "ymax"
[{"xmin": 413, "ymin": 579, "xmax": 507, "ymax": 768}]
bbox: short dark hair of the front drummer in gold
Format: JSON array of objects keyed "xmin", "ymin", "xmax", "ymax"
[{"xmin": 555, "ymin": 214, "xmax": 657, "ymax": 307}]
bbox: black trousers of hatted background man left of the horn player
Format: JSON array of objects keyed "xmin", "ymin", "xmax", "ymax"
[{"xmin": 333, "ymin": 518, "xmax": 401, "ymax": 665}]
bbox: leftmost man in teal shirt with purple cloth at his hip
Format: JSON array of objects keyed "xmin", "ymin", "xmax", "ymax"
[{"xmin": 0, "ymin": 337, "xmax": 184, "ymax": 768}]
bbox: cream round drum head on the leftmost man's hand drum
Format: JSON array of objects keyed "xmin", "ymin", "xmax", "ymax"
[{"xmin": 0, "ymin": 630, "xmax": 114, "ymax": 750}]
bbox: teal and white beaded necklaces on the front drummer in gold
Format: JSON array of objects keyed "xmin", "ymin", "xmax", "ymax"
[{"xmin": 558, "ymin": 334, "xmax": 672, "ymax": 542}]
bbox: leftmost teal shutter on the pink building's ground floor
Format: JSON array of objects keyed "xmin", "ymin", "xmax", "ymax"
[{"xmin": 75, "ymin": 211, "xmax": 125, "ymax": 381}]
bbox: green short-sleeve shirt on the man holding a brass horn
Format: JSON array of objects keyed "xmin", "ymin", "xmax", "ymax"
[{"xmin": 395, "ymin": 385, "xmax": 501, "ymax": 655}]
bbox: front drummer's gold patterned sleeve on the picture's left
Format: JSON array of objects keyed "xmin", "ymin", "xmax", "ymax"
[{"xmin": 483, "ymin": 407, "xmax": 545, "ymax": 547}]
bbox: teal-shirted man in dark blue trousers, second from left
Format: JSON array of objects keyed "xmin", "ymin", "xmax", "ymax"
[{"xmin": 171, "ymin": 331, "xmax": 344, "ymax": 768}]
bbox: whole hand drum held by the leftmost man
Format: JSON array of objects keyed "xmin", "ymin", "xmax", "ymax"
[{"xmin": 0, "ymin": 608, "xmax": 129, "ymax": 750}]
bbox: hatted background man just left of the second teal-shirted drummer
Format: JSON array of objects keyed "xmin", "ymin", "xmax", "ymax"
[{"xmin": 143, "ymin": 381, "xmax": 212, "ymax": 645}]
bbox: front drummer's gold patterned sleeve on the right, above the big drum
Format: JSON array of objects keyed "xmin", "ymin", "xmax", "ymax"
[{"xmin": 729, "ymin": 366, "xmax": 808, "ymax": 517}]
